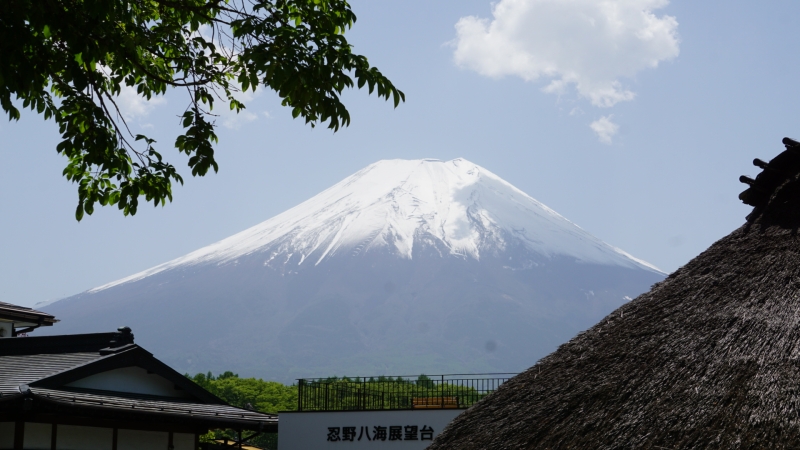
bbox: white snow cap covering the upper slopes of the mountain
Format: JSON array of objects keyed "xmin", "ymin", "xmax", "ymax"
[{"xmin": 91, "ymin": 158, "xmax": 661, "ymax": 292}]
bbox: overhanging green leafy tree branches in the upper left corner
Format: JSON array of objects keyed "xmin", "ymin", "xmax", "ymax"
[{"xmin": 0, "ymin": 0, "xmax": 405, "ymax": 220}]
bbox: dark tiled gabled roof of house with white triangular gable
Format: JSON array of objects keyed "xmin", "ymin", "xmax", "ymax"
[{"xmin": 0, "ymin": 329, "xmax": 278, "ymax": 431}]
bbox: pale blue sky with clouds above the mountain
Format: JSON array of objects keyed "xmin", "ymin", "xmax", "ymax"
[{"xmin": 0, "ymin": 0, "xmax": 800, "ymax": 305}]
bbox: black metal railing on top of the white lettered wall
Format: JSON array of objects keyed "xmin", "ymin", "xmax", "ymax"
[{"xmin": 297, "ymin": 373, "xmax": 516, "ymax": 411}]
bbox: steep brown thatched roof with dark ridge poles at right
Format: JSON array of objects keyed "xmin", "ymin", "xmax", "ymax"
[{"xmin": 429, "ymin": 141, "xmax": 800, "ymax": 450}]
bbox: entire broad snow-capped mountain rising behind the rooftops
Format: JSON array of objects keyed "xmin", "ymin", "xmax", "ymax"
[{"xmin": 44, "ymin": 159, "xmax": 664, "ymax": 382}]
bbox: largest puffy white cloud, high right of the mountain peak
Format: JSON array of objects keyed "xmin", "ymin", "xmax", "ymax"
[{"xmin": 454, "ymin": 0, "xmax": 679, "ymax": 107}]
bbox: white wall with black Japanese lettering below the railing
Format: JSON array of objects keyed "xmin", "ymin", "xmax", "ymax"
[{"xmin": 278, "ymin": 409, "xmax": 464, "ymax": 450}]
